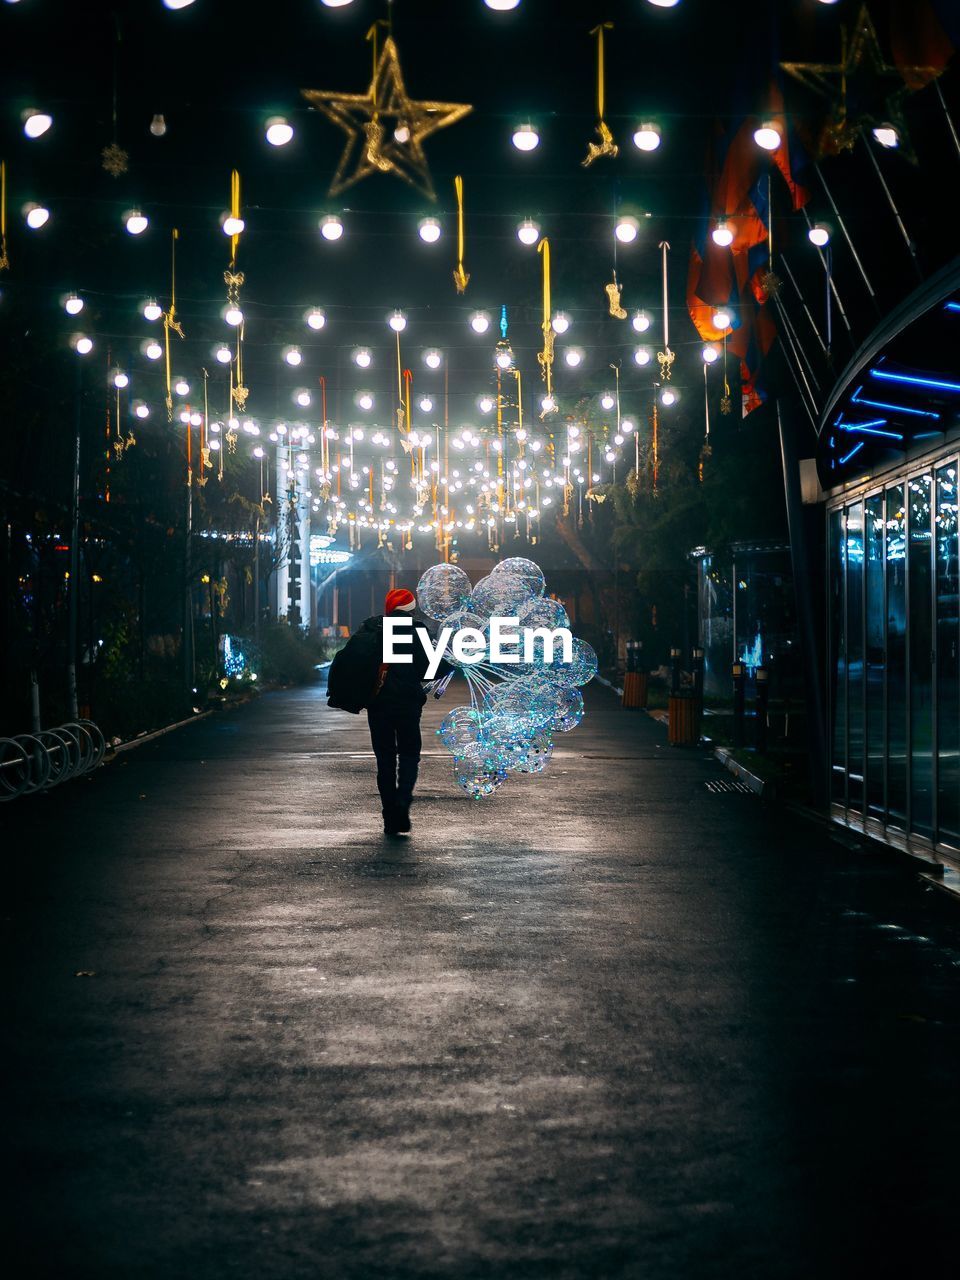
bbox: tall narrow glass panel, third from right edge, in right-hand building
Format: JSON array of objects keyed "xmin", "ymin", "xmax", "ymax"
[{"xmin": 886, "ymin": 485, "xmax": 906, "ymax": 827}]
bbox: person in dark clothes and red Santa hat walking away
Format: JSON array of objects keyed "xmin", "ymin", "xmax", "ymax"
[{"xmin": 361, "ymin": 588, "xmax": 454, "ymax": 836}]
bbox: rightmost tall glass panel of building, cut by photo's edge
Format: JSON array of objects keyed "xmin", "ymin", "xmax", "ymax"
[{"xmin": 934, "ymin": 462, "xmax": 960, "ymax": 847}]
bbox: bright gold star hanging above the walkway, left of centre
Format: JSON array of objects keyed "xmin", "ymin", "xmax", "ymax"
[{"xmin": 301, "ymin": 36, "xmax": 472, "ymax": 200}]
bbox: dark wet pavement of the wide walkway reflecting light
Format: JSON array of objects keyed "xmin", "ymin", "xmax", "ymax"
[{"xmin": 0, "ymin": 689, "xmax": 960, "ymax": 1280}]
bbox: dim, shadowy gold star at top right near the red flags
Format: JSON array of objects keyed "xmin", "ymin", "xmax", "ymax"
[{"xmin": 780, "ymin": 4, "xmax": 938, "ymax": 160}]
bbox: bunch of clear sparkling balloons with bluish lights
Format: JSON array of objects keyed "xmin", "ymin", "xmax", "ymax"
[{"xmin": 417, "ymin": 557, "xmax": 596, "ymax": 800}]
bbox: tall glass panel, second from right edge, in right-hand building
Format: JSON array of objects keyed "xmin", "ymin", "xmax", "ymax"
[{"xmin": 908, "ymin": 476, "xmax": 933, "ymax": 836}]
